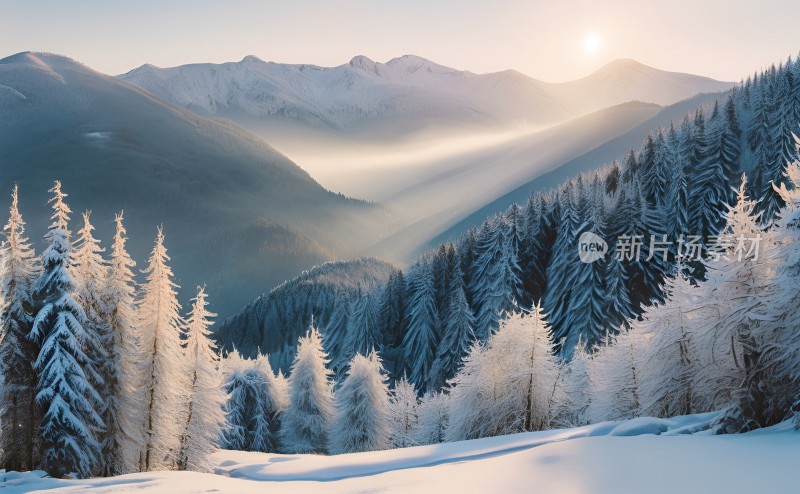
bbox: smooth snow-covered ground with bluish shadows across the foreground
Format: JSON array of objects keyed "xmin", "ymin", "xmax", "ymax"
[{"xmin": 6, "ymin": 415, "xmax": 800, "ymax": 494}]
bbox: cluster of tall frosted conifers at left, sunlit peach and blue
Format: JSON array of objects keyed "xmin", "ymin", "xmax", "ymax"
[{"xmin": 0, "ymin": 182, "xmax": 225, "ymax": 477}]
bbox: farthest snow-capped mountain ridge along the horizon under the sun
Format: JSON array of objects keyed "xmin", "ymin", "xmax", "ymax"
[{"xmin": 119, "ymin": 55, "xmax": 732, "ymax": 137}]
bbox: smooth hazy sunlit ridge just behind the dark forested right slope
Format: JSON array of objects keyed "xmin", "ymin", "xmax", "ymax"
[{"xmin": 370, "ymin": 102, "xmax": 661, "ymax": 261}]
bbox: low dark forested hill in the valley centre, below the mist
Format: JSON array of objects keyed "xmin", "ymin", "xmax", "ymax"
[{"xmin": 216, "ymin": 259, "xmax": 397, "ymax": 372}]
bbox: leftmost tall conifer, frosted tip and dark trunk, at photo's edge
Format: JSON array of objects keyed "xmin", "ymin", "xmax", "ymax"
[{"xmin": 0, "ymin": 185, "xmax": 39, "ymax": 471}]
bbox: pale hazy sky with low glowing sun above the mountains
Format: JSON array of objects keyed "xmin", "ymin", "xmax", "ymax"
[{"xmin": 0, "ymin": 0, "xmax": 800, "ymax": 81}]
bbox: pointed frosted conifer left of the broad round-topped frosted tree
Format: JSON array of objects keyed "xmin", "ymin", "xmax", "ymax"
[{"xmin": 280, "ymin": 326, "xmax": 334, "ymax": 453}]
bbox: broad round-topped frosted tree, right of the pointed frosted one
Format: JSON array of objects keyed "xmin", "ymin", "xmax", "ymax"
[{"xmin": 328, "ymin": 350, "xmax": 392, "ymax": 454}]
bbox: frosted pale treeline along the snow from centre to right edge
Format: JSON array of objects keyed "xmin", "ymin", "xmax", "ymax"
[{"xmin": 224, "ymin": 162, "xmax": 800, "ymax": 453}]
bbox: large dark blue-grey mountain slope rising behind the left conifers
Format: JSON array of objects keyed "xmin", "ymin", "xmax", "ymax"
[{"xmin": 0, "ymin": 53, "xmax": 388, "ymax": 315}]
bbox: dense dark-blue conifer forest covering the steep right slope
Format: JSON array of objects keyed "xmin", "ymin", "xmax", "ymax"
[{"xmin": 282, "ymin": 55, "xmax": 800, "ymax": 390}]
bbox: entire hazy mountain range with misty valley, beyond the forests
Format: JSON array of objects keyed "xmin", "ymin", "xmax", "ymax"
[{"xmin": 0, "ymin": 53, "xmax": 731, "ymax": 315}]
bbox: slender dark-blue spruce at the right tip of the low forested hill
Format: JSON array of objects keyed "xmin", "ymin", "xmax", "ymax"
[{"xmin": 403, "ymin": 258, "xmax": 439, "ymax": 390}]
